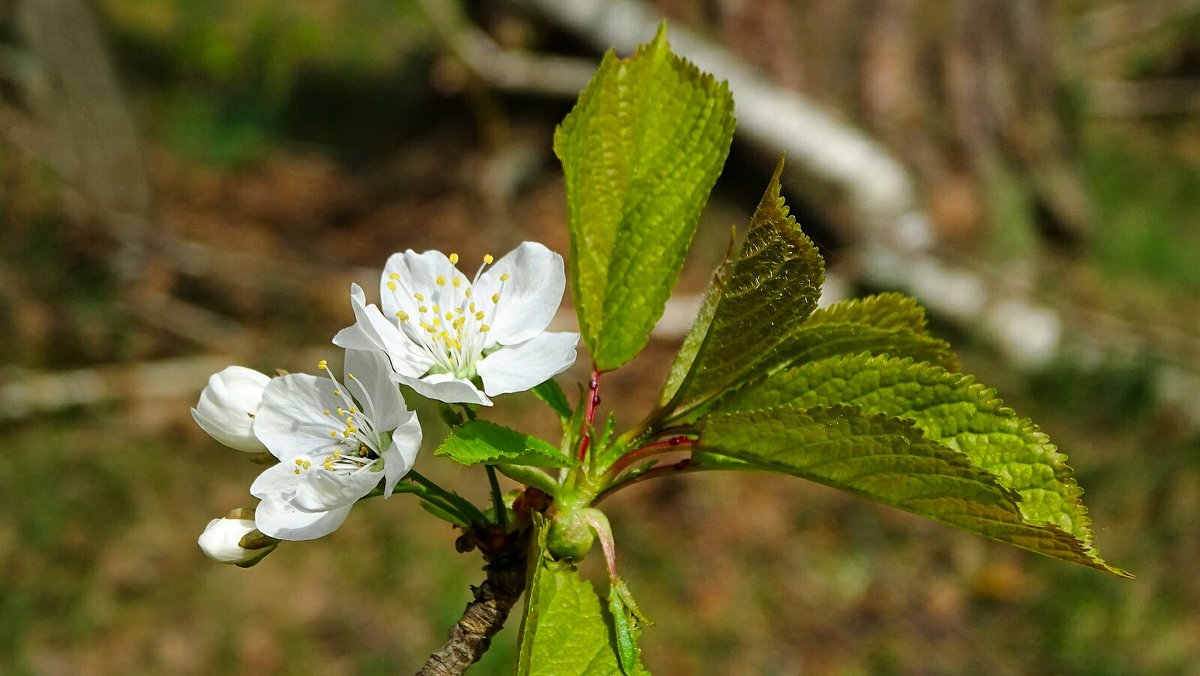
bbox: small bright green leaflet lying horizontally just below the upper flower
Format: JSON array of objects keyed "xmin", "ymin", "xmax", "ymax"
[{"xmin": 433, "ymin": 420, "xmax": 578, "ymax": 467}]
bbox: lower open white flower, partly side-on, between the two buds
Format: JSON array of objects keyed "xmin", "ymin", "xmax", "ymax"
[{"xmin": 250, "ymin": 349, "xmax": 421, "ymax": 540}]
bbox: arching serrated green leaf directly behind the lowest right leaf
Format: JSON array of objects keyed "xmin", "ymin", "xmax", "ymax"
[{"xmin": 719, "ymin": 354, "xmax": 1127, "ymax": 575}]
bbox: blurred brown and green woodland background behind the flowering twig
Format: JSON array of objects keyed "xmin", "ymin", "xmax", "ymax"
[{"xmin": 0, "ymin": 0, "xmax": 1200, "ymax": 675}]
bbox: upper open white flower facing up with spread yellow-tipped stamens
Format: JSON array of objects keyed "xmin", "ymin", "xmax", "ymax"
[{"xmin": 334, "ymin": 241, "xmax": 580, "ymax": 406}]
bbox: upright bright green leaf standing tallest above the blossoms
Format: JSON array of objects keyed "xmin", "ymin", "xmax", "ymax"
[{"xmin": 554, "ymin": 24, "xmax": 733, "ymax": 371}]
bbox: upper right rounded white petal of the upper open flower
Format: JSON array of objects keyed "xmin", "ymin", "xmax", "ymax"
[{"xmin": 473, "ymin": 241, "xmax": 566, "ymax": 345}]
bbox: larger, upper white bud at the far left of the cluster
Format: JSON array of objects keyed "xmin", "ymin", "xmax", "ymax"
[{"xmin": 192, "ymin": 366, "xmax": 271, "ymax": 453}]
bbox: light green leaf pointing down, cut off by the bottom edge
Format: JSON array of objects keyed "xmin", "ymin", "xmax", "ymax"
[{"xmin": 517, "ymin": 525, "xmax": 649, "ymax": 676}]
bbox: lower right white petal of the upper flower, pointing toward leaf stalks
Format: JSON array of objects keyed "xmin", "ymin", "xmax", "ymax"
[{"xmin": 478, "ymin": 333, "xmax": 580, "ymax": 396}]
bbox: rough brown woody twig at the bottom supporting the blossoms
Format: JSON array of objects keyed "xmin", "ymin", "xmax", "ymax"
[{"xmin": 418, "ymin": 528, "xmax": 529, "ymax": 676}]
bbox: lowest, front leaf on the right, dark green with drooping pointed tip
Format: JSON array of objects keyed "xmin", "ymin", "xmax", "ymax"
[{"xmin": 701, "ymin": 406, "xmax": 1128, "ymax": 575}]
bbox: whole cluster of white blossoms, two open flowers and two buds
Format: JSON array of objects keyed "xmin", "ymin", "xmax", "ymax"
[{"xmin": 192, "ymin": 241, "xmax": 578, "ymax": 564}]
